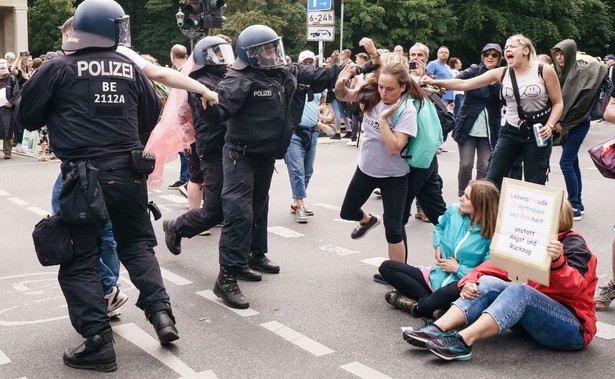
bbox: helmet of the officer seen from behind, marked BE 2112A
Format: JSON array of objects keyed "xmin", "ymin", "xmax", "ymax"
[{"xmin": 62, "ymin": 0, "xmax": 130, "ymax": 51}]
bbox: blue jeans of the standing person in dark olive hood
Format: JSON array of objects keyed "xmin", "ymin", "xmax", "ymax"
[{"xmin": 559, "ymin": 121, "xmax": 589, "ymax": 209}]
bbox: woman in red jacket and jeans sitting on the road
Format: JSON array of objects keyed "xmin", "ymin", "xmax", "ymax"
[{"xmin": 403, "ymin": 201, "xmax": 598, "ymax": 361}]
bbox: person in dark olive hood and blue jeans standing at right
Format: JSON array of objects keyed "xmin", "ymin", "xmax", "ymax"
[{"xmin": 551, "ymin": 39, "xmax": 607, "ymax": 221}]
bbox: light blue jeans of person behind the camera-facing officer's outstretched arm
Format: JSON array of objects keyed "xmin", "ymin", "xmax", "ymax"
[{"xmin": 284, "ymin": 129, "xmax": 318, "ymax": 199}]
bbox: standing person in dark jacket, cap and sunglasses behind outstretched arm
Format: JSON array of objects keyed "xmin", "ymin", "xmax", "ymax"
[{"xmin": 453, "ymin": 43, "xmax": 502, "ymax": 196}]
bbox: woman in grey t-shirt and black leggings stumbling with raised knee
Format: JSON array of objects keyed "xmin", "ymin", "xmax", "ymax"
[{"xmin": 335, "ymin": 38, "xmax": 428, "ymax": 281}]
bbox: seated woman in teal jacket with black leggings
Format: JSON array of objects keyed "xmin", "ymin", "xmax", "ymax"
[{"xmin": 379, "ymin": 180, "xmax": 500, "ymax": 318}]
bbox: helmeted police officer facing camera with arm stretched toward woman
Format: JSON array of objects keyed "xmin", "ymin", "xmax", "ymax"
[{"xmin": 204, "ymin": 25, "xmax": 340, "ymax": 308}]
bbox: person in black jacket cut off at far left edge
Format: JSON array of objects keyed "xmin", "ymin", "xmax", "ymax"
[{"xmin": 0, "ymin": 59, "xmax": 19, "ymax": 159}]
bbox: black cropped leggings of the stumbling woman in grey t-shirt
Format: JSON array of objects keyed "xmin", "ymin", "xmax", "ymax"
[{"xmin": 340, "ymin": 167, "xmax": 408, "ymax": 243}]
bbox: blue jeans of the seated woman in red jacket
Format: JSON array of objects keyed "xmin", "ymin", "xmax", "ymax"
[{"xmin": 453, "ymin": 276, "xmax": 584, "ymax": 350}]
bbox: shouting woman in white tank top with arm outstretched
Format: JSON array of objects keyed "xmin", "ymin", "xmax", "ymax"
[{"xmin": 421, "ymin": 34, "xmax": 564, "ymax": 187}]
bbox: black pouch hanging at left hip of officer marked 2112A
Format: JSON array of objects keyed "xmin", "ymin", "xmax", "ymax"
[{"xmin": 32, "ymin": 216, "xmax": 75, "ymax": 266}]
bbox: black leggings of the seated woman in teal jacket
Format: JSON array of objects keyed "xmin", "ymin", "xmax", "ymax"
[{"xmin": 378, "ymin": 260, "xmax": 460, "ymax": 318}]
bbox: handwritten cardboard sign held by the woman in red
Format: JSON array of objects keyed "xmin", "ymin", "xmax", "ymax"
[{"xmin": 491, "ymin": 178, "xmax": 564, "ymax": 286}]
